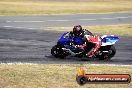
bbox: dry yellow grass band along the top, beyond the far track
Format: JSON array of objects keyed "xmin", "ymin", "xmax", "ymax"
[{"xmin": 0, "ymin": 0, "xmax": 132, "ymax": 15}]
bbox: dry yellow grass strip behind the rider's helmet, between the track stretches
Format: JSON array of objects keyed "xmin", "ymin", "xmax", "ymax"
[{"xmin": 48, "ymin": 24, "xmax": 132, "ymax": 36}]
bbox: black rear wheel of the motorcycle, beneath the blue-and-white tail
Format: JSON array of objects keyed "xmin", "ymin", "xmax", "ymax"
[{"xmin": 97, "ymin": 45, "xmax": 116, "ymax": 60}]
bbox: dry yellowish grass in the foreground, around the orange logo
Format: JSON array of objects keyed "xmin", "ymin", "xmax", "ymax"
[{"xmin": 0, "ymin": 64, "xmax": 132, "ymax": 88}]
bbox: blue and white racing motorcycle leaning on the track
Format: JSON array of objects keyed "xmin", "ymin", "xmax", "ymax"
[{"xmin": 51, "ymin": 30, "xmax": 119, "ymax": 60}]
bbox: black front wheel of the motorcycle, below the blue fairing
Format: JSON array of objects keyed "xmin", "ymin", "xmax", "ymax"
[{"xmin": 51, "ymin": 45, "xmax": 65, "ymax": 58}]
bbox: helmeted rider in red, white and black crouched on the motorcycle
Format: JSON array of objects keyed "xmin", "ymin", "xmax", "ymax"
[{"xmin": 70, "ymin": 25, "xmax": 101, "ymax": 58}]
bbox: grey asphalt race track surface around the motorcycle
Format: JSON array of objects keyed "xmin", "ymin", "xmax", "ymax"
[{"xmin": 0, "ymin": 13, "xmax": 132, "ymax": 65}]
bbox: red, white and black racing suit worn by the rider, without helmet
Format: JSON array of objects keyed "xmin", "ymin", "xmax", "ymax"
[{"xmin": 69, "ymin": 29, "xmax": 101, "ymax": 58}]
